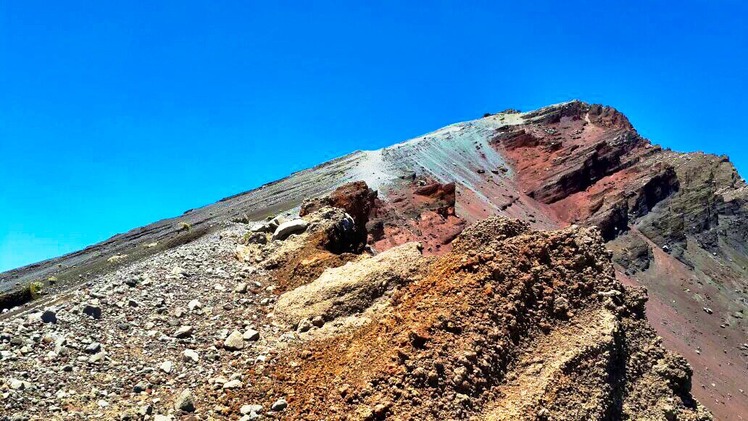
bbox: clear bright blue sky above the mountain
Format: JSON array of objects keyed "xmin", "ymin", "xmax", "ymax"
[{"xmin": 0, "ymin": 0, "xmax": 748, "ymax": 270}]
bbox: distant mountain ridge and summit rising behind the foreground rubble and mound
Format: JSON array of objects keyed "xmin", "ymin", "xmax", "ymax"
[{"xmin": 0, "ymin": 100, "xmax": 748, "ymax": 419}]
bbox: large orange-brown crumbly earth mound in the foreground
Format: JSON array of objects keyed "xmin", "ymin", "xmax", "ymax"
[{"xmin": 229, "ymin": 218, "xmax": 710, "ymax": 420}]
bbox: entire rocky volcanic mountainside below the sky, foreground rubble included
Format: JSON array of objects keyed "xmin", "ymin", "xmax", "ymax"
[{"xmin": 0, "ymin": 101, "xmax": 748, "ymax": 419}]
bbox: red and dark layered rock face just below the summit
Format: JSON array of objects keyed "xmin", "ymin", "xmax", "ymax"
[{"xmin": 491, "ymin": 105, "xmax": 678, "ymax": 239}]
